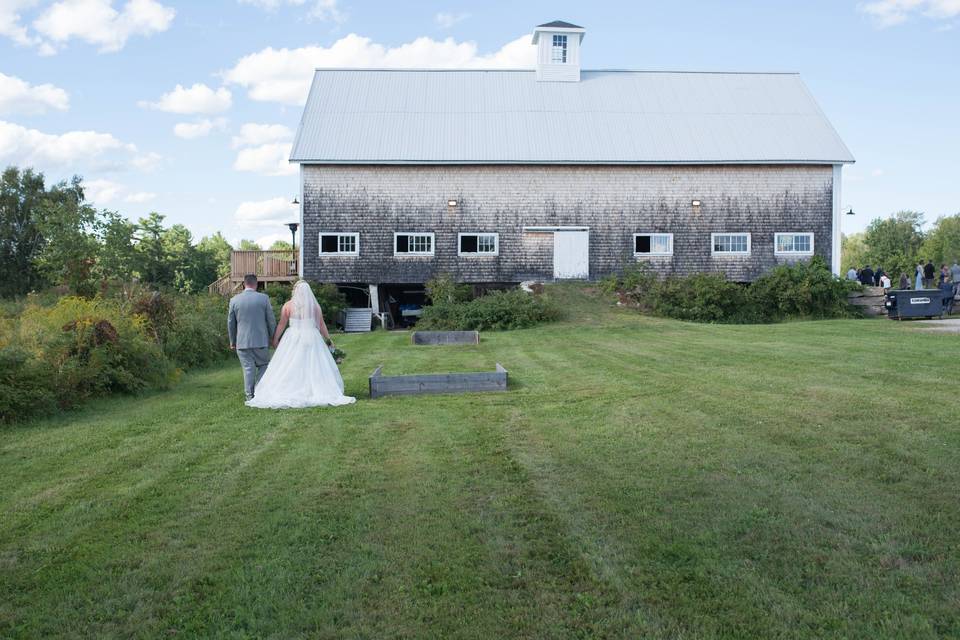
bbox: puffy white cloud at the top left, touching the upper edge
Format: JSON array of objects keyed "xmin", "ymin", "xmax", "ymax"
[{"xmin": 33, "ymin": 0, "xmax": 176, "ymax": 54}]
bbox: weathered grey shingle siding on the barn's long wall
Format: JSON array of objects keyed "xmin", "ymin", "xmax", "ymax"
[{"xmin": 303, "ymin": 165, "xmax": 833, "ymax": 283}]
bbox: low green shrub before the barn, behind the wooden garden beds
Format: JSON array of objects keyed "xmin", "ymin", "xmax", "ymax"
[{"xmin": 417, "ymin": 289, "xmax": 560, "ymax": 331}]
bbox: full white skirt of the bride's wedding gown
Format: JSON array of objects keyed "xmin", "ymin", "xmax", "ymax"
[{"xmin": 247, "ymin": 317, "xmax": 356, "ymax": 409}]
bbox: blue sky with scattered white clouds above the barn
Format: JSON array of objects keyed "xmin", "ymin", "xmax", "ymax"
[{"xmin": 0, "ymin": 0, "xmax": 960, "ymax": 246}]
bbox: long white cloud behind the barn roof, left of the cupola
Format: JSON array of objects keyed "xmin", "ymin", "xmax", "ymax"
[{"xmin": 223, "ymin": 33, "xmax": 536, "ymax": 105}]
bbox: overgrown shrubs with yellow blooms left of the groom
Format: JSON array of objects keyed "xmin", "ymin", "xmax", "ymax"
[{"xmin": 0, "ymin": 284, "xmax": 230, "ymax": 423}]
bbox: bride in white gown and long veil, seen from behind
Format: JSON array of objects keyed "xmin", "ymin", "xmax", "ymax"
[{"xmin": 247, "ymin": 280, "xmax": 356, "ymax": 409}]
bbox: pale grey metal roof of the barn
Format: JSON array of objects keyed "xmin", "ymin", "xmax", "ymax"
[{"xmin": 290, "ymin": 69, "xmax": 854, "ymax": 164}]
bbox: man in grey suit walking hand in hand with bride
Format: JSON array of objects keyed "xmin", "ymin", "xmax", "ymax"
[{"xmin": 227, "ymin": 274, "xmax": 277, "ymax": 400}]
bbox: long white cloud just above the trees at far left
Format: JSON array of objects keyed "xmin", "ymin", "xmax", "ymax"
[{"xmin": 0, "ymin": 120, "xmax": 160, "ymax": 173}]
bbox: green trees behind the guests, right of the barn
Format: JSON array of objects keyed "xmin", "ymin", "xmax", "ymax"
[{"xmin": 842, "ymin": 211, "xmax": 960, "ymax": 282}]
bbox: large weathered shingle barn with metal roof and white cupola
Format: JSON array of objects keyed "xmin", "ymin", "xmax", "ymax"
[{"xmin": 290, "ymin": 21, "xmax": 853, "ymax": 320}]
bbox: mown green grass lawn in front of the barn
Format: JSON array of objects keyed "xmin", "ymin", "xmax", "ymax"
[{"xmin": 0, "ymin": 286, "xmax": 960, "ymax": 639}]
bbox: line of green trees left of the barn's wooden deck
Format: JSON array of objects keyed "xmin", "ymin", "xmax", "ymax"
[{"xmin": 0, "ymin": 167, "xmax": 289, "ymax": 297}]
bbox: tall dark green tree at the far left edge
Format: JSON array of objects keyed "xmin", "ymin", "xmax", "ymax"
[{"xmin": 0, "ymin": 167, "xmax": 47, "ymax": 297}]
